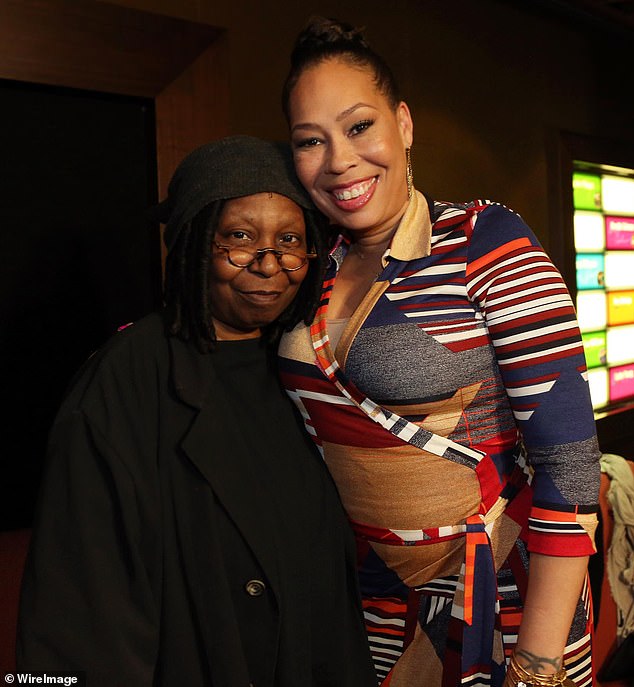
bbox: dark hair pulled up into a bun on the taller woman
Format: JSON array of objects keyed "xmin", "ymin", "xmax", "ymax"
[{"xmin": 282, "ymin": 16, "xmax": 401, "ymax": 121}]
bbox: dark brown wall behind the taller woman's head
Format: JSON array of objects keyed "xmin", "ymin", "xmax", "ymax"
[{"xmin": 111, "ymin": 0, "xmax": 634, "ymax": 249}]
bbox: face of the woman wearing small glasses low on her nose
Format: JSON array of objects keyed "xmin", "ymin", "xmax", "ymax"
[{"xmin": 209, "ymin": 193, "xmax": 308, "ymax": 339}]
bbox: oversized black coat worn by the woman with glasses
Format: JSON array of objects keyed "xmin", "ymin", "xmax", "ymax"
[{"xmin": 18, "ymin": 315, "xmax": 376, "ymax": 687}]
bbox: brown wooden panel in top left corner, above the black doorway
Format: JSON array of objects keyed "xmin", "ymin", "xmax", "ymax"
[{"xmin": 0, "ymin": 0, "xmax": 219, "ymax": 97}]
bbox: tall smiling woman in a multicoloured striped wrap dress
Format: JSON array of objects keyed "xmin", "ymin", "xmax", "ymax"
[{"xmin": 280, "ymin": 19, "xmax": 599, "ymax": 687}]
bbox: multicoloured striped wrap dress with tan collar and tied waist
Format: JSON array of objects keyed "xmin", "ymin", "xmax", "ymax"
[{"xmin": 279, "ymin": 191, "xmax": 600, "ymax": 687}]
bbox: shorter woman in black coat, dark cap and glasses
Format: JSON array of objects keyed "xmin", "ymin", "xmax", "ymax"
[{"xmin": 18, "ymin": 136, "xmax": 374, "ymax": 687}]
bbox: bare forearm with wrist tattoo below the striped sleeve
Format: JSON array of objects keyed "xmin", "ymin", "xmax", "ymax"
[{"xmin": 515, "ymin": 553, "xmax": 588, "ymax": 674}]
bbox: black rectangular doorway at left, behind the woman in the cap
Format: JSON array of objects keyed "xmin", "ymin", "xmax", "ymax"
[{"xmin": 0, "ymin": 81, "xmax": 161, "ymax": 529}]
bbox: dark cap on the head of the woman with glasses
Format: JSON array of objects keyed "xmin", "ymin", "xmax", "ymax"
[{"xmin": 152, "ymin": 136, "xmax": 315, "ymax": 250}]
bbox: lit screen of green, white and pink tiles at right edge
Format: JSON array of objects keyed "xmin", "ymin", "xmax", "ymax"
[{"xmin": 572, "ymin": 163, "xmax": 634, "ymax": 410}]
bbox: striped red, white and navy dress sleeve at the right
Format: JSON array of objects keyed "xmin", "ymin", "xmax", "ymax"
[{"xmin": 466, "ymin": 205, "xmax": 600, "ymax": 556}]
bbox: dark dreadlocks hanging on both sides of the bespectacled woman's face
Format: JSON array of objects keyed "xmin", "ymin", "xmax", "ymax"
[{"xmin": 163, "ymin": 200, "xmax": 329, "ymax": 353}]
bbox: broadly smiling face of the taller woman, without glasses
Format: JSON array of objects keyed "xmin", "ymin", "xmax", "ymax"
[{"xmin": 289, "ymin": 58, "xmax": 413, "ymax": 242}]
